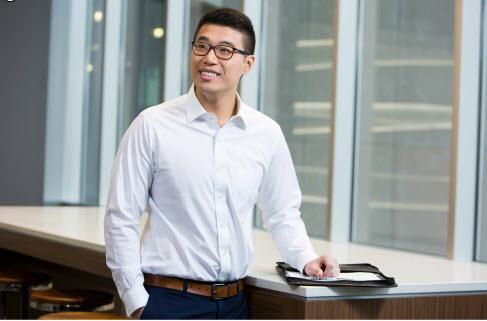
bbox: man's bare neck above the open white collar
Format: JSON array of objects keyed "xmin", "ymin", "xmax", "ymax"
[{"xmin": 195, "ymin": 87, "xmax": 237, "ymax": 127}]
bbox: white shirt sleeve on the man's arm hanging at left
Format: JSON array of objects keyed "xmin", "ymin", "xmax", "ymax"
[{"xmin": 105, "ymin": 115, "xmax": 154, "ymax": 315}]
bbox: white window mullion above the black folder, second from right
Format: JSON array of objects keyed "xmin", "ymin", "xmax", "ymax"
[{"xmin": 328, "ymin": 1, "xmax": 359, "ymax": 242}]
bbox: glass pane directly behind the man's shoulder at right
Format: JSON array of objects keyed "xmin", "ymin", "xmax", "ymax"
[{"xmin": 257, "ymin": 0, "xmax": 334, "ymax": 238}]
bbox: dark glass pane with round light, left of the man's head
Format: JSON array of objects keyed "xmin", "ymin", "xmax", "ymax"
[{"xmin": 118, "ymin": 0, "xmax": 166, "ymax": 139}]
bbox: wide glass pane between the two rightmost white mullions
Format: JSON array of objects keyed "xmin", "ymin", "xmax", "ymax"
[{"xmin": 352, "ymin": 0, "xmax": 454, "ymax": 256}]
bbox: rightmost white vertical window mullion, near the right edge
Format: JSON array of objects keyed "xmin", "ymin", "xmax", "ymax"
[{"xmin": 448, "ymin": 0, "xmax": 482, "ymax": 261}]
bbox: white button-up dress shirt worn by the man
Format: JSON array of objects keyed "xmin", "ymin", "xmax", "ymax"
[{"xmin": 105, "ymin": 87, "xmax": 318, "ymax": 315}]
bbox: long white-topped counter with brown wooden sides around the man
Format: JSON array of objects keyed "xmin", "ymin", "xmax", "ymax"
[{"xmin": 0, "ymin": 207, "xmax": 487, "ymax": 319}]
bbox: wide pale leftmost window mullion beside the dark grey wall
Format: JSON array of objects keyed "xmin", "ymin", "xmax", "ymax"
[{"xmin": 44, "ymin": 1, "xmax": 88, "ymax": 204}]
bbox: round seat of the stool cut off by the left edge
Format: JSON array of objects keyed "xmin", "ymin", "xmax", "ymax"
[{"xmin": 0, "ymin": 270, "xmax": 52, "ymax": 290}]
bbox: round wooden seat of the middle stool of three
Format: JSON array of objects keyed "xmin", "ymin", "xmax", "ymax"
[{"xmin": 30, "ymin": 289, "xmax": 115, "ymax": 312}]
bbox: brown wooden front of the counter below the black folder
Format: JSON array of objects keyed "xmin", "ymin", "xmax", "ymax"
[{"xmin": 247, "ymin": 286, "xmax": 487, "ymax": 319}]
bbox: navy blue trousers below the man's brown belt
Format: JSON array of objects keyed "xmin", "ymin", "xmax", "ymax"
[{"xmin": 140, "ymin": 285, "xmax": 250, "ymax": 320}]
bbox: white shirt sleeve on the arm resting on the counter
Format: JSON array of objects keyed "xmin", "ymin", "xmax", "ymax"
[{"xmin": 257, "ymin": 129, "xmax": 318, "ymax": 271}]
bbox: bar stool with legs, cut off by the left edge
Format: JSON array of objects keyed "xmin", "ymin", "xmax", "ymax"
[{"xmin": 0, "ymin": 269, "xmax": 52, "ymax": 319}]
